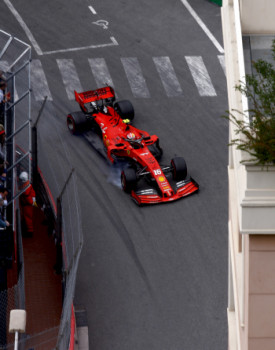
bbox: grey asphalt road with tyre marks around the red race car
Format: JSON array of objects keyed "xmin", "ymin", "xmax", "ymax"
[{"xmin": 0, "ymin": 0, "xmax": 228, "ymax": 350}]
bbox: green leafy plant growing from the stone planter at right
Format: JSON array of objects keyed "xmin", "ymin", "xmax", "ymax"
[{"xmin": 225, "ymin": 40, "xmax": 275, "ymax": 165}]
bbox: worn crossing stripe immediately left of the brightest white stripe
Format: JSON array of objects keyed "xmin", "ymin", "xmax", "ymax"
[{"xmin": 153, "ymin": 57, "xmax": 182, "ymax": 97}]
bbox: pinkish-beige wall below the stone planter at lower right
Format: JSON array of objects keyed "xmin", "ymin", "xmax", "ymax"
[{"xmin": 248, "ymin": 235, "xmax": 275, "ymax": 350}]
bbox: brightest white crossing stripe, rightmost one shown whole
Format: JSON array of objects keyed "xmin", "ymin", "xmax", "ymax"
[{"xmin": 185, "ymin": 56, "xmax": 217, "ymax": 96}]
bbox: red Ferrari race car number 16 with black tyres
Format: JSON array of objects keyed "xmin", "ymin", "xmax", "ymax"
[{"xmin": 67, "ymin": 86, "xmax": 199, "ymax": 205}]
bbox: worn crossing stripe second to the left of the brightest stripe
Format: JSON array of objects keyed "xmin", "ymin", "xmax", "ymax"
[{"xmin": 121, "ymin": 57, "xmax": 150, "ymax": 98}]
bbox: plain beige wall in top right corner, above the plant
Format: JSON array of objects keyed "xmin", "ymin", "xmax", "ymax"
[{"xmin": 240, "ymin": 0, "xmax": 275, "ymax": 34}]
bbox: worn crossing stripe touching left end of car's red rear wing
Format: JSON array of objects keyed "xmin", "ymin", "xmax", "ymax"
[{"xmin": 56, "ymin": 59, "xmax": 83, "ymax": 100}]
